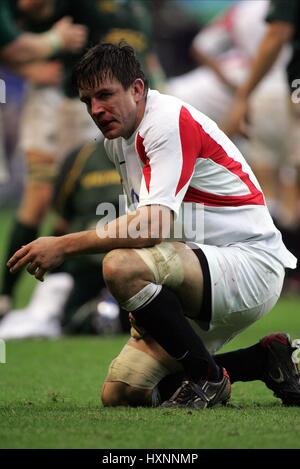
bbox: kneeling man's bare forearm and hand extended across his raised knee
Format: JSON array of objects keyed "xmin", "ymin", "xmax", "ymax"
[{"xmin": 7, "ymin": 205, "xmax": 172, "ymax": 281}]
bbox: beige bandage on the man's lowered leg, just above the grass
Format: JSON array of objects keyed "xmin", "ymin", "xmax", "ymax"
[{"xmin": 105, "ymin": 344, "xmax": 170, "ymax": 389}]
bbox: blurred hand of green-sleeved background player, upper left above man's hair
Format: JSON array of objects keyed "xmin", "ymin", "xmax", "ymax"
[{"xmin": 52, "ymin": 16, "xmax": 88, "ymax": 52}]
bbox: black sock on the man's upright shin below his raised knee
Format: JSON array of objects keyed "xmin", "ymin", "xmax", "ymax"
[{"xmin": 132, "ymin": 287, "xmax": 220, "ymax": 381}]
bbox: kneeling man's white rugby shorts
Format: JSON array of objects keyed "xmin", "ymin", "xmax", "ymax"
[{"xmin": 189, "ymin": 244, "xmax": 285, "ymax": 353}]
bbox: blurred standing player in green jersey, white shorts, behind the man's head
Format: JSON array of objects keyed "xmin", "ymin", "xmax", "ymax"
[{"xmin": 0, "ymin": 0, "xmax": 163, "ymax": 314}]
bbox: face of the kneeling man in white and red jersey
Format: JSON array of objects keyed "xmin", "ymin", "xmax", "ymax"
[{"xmin": 79, "ymin": 78, "xmax": 144, "ymax": 139}]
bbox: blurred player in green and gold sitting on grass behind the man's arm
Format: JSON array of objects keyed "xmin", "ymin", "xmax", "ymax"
[{"xmin": 0, "ymin": 138, "xmax": 128, "ymax": 339}]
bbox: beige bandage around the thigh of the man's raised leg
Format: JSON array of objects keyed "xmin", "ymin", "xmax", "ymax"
[{"xmin": 134, "ymin": 242, "xmax": 184, "ymax": 288}]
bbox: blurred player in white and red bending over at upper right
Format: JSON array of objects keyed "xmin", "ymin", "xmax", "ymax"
[{"xmin": 166, "ymin": 0, "xmax": 289, "ymax": 216}]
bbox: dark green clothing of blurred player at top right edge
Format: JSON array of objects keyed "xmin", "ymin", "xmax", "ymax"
[{"xmin": 266, "ymin": 0, "xmax": 300, "ymax": 88}]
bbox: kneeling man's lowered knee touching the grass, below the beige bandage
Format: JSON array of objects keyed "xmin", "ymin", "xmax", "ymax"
[{"xmin": 101, "ymin": 381, "xmax": 152, "ymax": 407}]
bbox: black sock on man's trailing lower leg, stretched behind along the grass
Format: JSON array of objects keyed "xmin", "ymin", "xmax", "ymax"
[{"xmin": 214, "ymin": 343, "xmax": 266, "ymax": 383}]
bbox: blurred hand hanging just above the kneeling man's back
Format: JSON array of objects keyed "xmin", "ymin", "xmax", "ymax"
[{"xmin": 220, "ymin": 97, "xmax": 249, "ymax": 138}]
